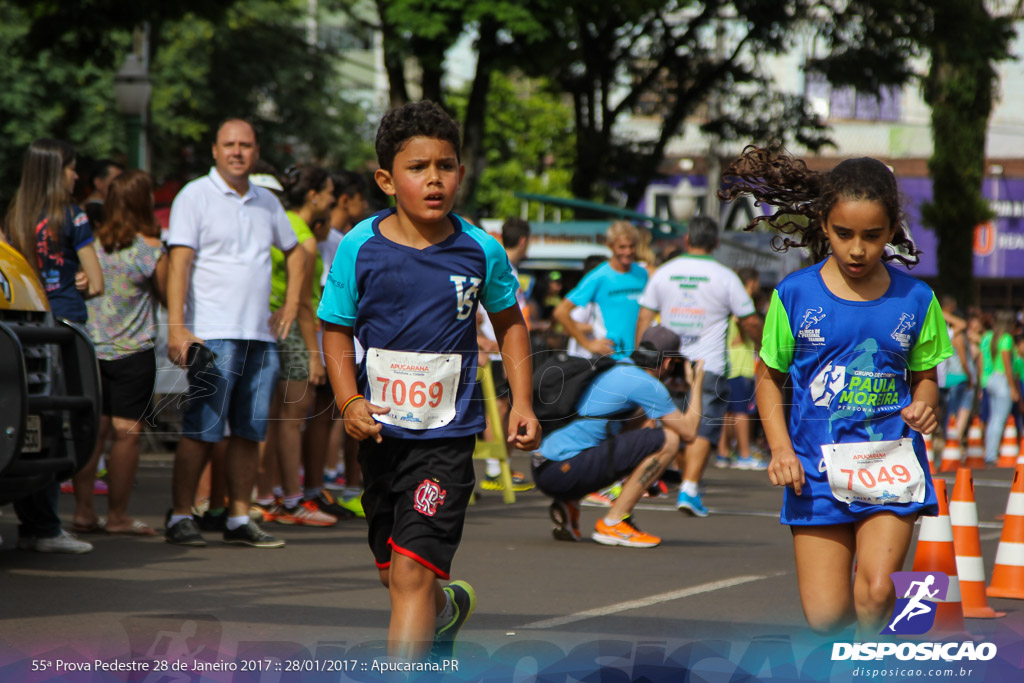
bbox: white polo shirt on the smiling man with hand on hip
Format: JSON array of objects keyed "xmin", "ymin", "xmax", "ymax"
[{"xmin": 167, "ymin": 167, "xmax": 298, "ymax": 341}]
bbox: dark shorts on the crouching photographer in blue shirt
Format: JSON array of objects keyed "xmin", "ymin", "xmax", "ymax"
[{"xmin": 534, "ymin": 428, "xmax": 665, "ymax": 501}]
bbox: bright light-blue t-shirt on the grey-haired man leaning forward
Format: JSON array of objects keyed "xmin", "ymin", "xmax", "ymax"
[{"xmin": 566, "ymin": 262, "xmax": 647, "ymax": 359}]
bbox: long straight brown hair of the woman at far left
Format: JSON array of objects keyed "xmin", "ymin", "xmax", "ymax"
[{"xmin": 5, "ymin": 137, "xmax": 76, "ymax": 276}]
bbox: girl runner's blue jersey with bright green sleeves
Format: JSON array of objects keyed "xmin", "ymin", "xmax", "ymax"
[{"xmin": 759, "ymin": 263, "xmax": 952, "ymax": 525}]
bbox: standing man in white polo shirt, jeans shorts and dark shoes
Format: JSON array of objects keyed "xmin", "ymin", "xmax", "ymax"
[{"xmin": 164, "ymin": 119, "xmax": 307, "ymax": 548}]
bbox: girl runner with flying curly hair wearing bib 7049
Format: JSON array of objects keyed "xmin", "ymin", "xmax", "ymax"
[{"xmin": 721, "ymin": 147, "xmax": 952, "ymax": 637}]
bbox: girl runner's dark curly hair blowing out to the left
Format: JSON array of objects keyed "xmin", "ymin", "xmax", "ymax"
[{"xmin": 718, "ymin": 145, "xmax": 921, "ymax": 266}]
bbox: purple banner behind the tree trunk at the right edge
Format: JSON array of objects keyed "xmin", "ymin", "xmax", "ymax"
[{"xmin": 899, "ymin": 176, "xmax": 1024, "ymax": 279}]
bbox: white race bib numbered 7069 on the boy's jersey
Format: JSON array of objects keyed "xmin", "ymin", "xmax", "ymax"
[{"xmin": 367, "ymin": 348, "xmax": 462, "ymax": 430}]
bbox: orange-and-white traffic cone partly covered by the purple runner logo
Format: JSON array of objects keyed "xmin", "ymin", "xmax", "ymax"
[{"xmin": 912, "ymin": 479, "xmax": 966, "ymax": 633}]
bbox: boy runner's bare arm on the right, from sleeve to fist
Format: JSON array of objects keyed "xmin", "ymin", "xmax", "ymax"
[{"xmin": 488, "ymin": 299, "xmax": 540, "ymax": 451}]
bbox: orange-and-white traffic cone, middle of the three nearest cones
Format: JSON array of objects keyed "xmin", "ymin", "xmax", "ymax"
[{"xmin": 949, "ymin": 467, "xmax": 1007, "ymax": 618}]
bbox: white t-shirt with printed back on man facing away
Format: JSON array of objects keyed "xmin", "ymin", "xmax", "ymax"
[{"xmin": 640, "ymin": 255, "xmax": 754, "ymax": 375}]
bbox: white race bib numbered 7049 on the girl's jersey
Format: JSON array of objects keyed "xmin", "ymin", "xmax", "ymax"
[{"xmin": 821, "ymin": 438, "xmax": 927, "ymax": 505}]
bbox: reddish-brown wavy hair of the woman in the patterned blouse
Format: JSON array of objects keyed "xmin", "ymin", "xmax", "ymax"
[{"xmin": 94, "ymin": 169, "xmax": 160, "ymax": 254}]
